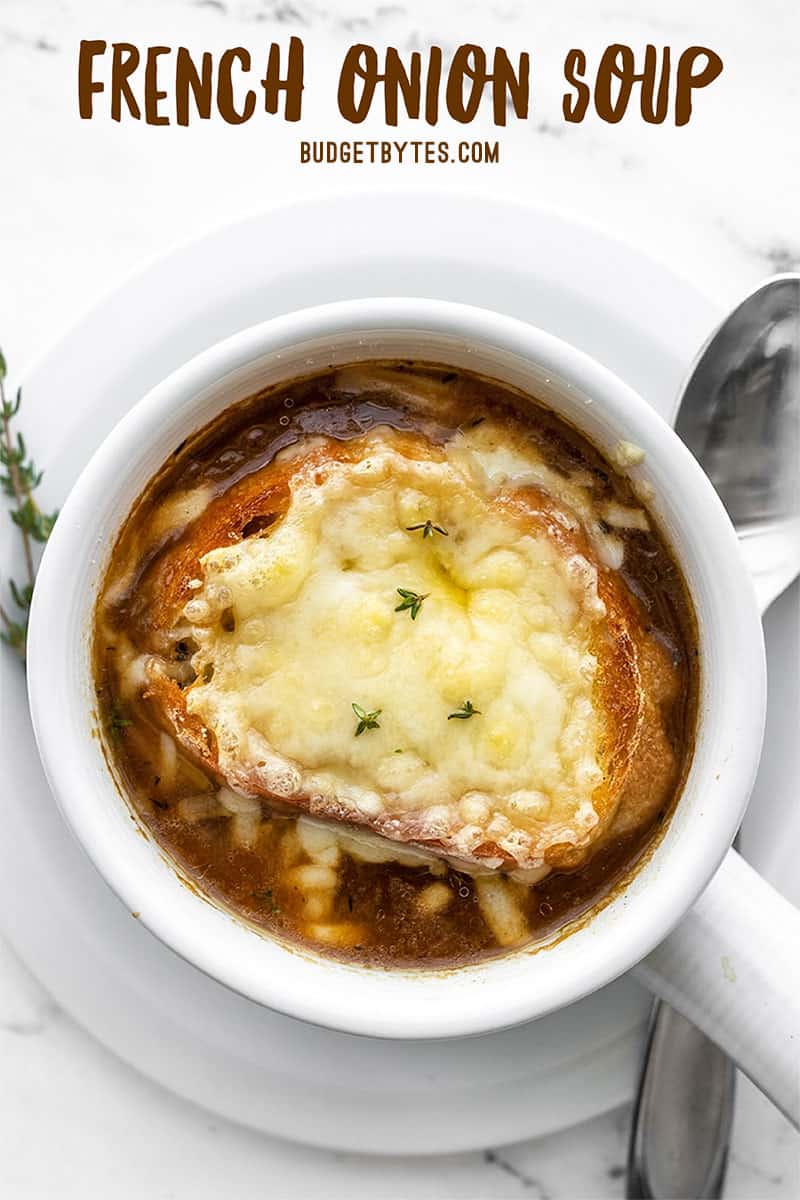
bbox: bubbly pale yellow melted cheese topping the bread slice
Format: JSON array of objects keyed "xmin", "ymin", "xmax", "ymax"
[{"xmin": 178, "ymin": 426, "xmax": 623, "ymax": 869}]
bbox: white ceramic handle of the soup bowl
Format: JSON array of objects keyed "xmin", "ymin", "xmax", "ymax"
[{"xmin": 636, "ymin": 850, "xmax": 800, "ymax": 1128}]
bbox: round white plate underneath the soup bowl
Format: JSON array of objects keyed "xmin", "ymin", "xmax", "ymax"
[{"xmin": 0, "ymin": 197, "xmax": 800, "ymax": 1153}]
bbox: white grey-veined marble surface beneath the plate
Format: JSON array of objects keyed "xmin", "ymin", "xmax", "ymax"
[{"xmin": 0, "ymin": 0, "xmax": 800, "ymax": 1200}]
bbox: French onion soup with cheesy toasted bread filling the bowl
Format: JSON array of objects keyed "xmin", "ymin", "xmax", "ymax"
[{"xmin": 94, "ymin": 361, "xmax": 698, "ymax": 965}]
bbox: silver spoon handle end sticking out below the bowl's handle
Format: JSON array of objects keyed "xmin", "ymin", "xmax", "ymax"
[{"xmin": 627, "ymin": 1000, "xmax": 736, "ymax": 1200}]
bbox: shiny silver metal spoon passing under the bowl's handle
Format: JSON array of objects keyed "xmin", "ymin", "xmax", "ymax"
[{"xmin": 627, "ymin": 275, "xmax": 800, "ymax": 1200}]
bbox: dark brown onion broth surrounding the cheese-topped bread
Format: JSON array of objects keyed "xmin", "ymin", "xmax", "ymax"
[{"xmin": 94, "ymin": 362, "xmax": 698, "ymax": 966}]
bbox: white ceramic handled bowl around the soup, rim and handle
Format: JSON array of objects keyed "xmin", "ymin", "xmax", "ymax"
[{"xmin": 29, "ymin": 299, "xmax": 800, "ymax": 1108}]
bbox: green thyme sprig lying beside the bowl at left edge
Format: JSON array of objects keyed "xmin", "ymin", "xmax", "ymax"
[{"xmin": 0, "ymin": 352, "xmax": 58, "ymax": 662}]
